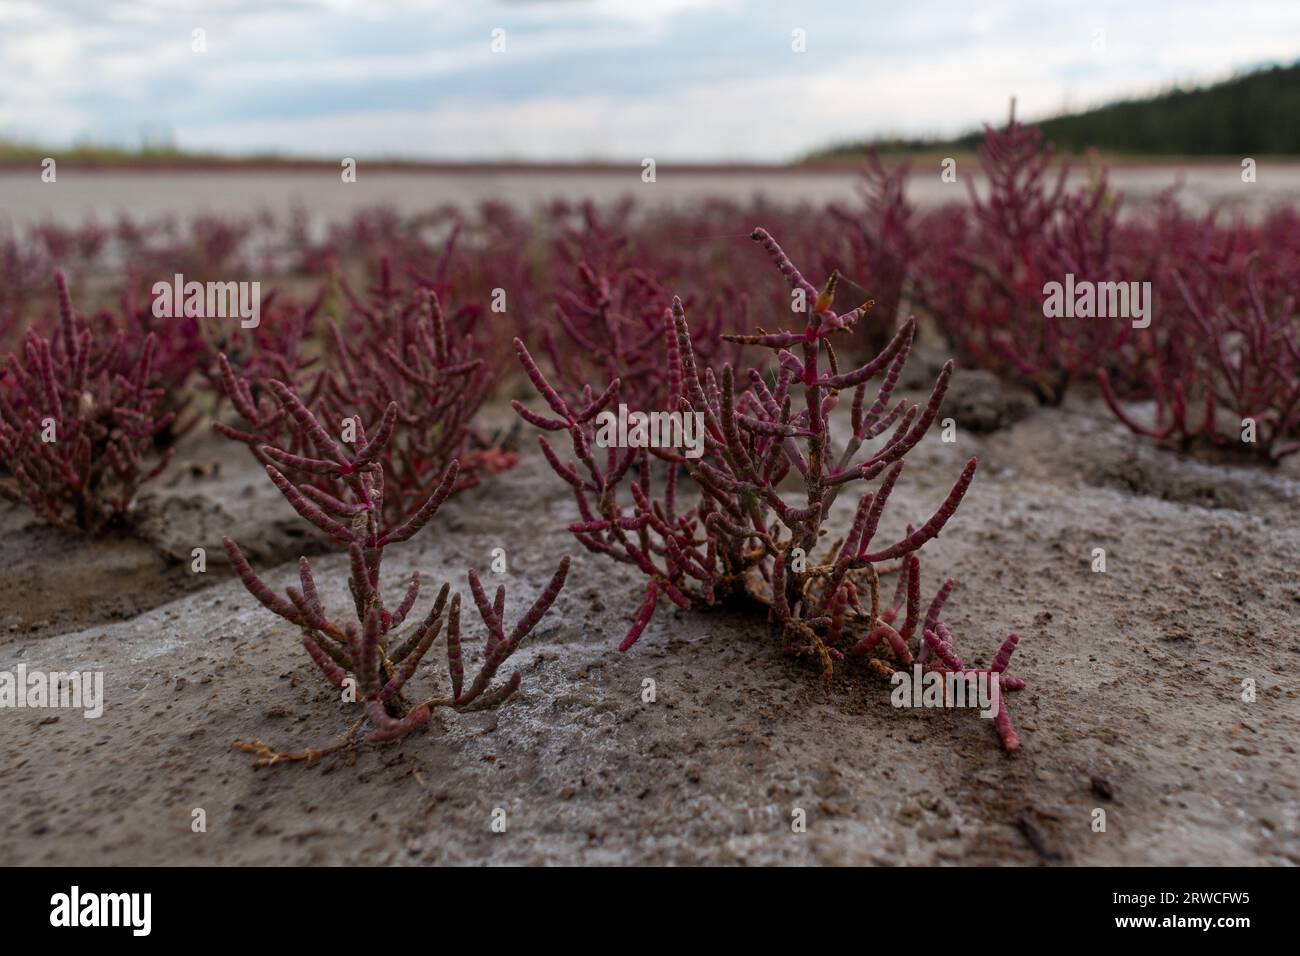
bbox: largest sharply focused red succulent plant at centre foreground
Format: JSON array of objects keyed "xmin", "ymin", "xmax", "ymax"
[{"xmin": 515, "ymin": 229, "xmax": 1015, "ymax": 749}]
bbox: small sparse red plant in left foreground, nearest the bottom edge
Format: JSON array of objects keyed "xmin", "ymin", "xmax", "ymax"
[{"xmin": 225, "ymin": 381, "xmax": 569, "ymax": 766}]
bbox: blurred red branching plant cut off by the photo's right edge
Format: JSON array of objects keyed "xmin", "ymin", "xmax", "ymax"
[{"xmin": 1097, "ymin": 198, "xmax": 1300, "ymax": 462}]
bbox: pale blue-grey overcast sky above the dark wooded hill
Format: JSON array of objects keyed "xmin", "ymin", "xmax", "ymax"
[{"xmin": 0, "ymin": 0, "xmax": 1300, "ymax": 163}]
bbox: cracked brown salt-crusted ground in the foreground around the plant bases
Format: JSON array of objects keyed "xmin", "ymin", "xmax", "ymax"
[{"xmin": 0, "ymin": 377, "xmax": 1300, "ymax": 865}]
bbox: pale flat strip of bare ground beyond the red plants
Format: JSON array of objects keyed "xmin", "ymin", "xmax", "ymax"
[{"xmin": 0, "ymin": 164, "xmax": 1300, "ymax": 225}]
